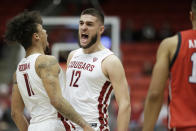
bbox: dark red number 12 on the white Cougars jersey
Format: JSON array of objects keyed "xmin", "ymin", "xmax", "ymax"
[{"xmin": 69, "ymin": 70, "xmax": 81, "ymax": 87}]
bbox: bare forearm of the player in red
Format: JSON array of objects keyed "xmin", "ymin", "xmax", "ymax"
[{"xmin": 143, "ymin": 92, "xmax": 163, "ymax": 131}]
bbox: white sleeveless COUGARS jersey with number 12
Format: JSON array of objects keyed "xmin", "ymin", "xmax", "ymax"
[{"xmin": 64, "ymin": 48, "xmax": 113, "ymax": 131}]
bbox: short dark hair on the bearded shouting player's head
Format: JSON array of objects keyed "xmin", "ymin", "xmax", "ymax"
[{"xmin": 81, "ymin": 8, "xmax": 104, "ymax": 24}]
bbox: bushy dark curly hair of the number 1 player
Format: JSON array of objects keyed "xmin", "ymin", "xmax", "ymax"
[{"xmin": 5, "ymin": 11, "xmax": 42, "ymax": 50}]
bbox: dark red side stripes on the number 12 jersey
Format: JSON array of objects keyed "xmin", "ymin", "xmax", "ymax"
[{"xmin": 98, "ymin": 81, "xmax": 112, "ymax": 131}]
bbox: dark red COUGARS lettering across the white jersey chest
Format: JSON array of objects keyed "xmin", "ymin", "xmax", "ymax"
[{"xmin": 68, "ymin": 61, "xmax": 95, "ymax": 72}]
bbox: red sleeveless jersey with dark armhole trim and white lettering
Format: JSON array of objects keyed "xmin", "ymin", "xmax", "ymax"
[{"xmin": 168, "ymin": 30, "xmax": 196, "ymax": 127}]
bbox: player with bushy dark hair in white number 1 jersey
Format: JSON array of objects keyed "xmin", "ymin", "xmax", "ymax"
[{"xmin": 5, "ymin": 11, "xmax": 93, "ymax": 131}]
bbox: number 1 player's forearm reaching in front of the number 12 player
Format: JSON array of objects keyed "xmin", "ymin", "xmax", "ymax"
[{"xmin": 52, "ymin": 99, "xmax": 88, "ymax": 128}]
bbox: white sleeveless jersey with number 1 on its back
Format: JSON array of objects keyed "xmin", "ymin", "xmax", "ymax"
[{"xmin": 16, "ymin": 54, "xmax": 72, "ymax": 131}]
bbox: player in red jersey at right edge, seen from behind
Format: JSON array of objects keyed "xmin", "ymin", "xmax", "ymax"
[{"xmin": 143, "ymin": 0, "xmax": 196, "ymax": 131}]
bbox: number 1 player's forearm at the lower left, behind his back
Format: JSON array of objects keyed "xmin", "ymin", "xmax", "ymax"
[{"xmin": 11, "ymin": 113, "xmax": 29, "ymax": 131}]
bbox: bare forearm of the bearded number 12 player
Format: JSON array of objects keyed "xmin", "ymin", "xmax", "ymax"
[{"xmin": 117, "ymin": 103, "xmax": 131, "ymax": 131}]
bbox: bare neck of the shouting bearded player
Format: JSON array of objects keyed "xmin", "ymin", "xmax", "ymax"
[{"xmin": 83, "ymin": 42, "xmax": 105, "ymax": 54}]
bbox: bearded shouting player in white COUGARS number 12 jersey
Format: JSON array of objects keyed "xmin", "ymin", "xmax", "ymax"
[{"xmin": 64, "ymin": 8, "xmax": 131, "ymax": 131}]
